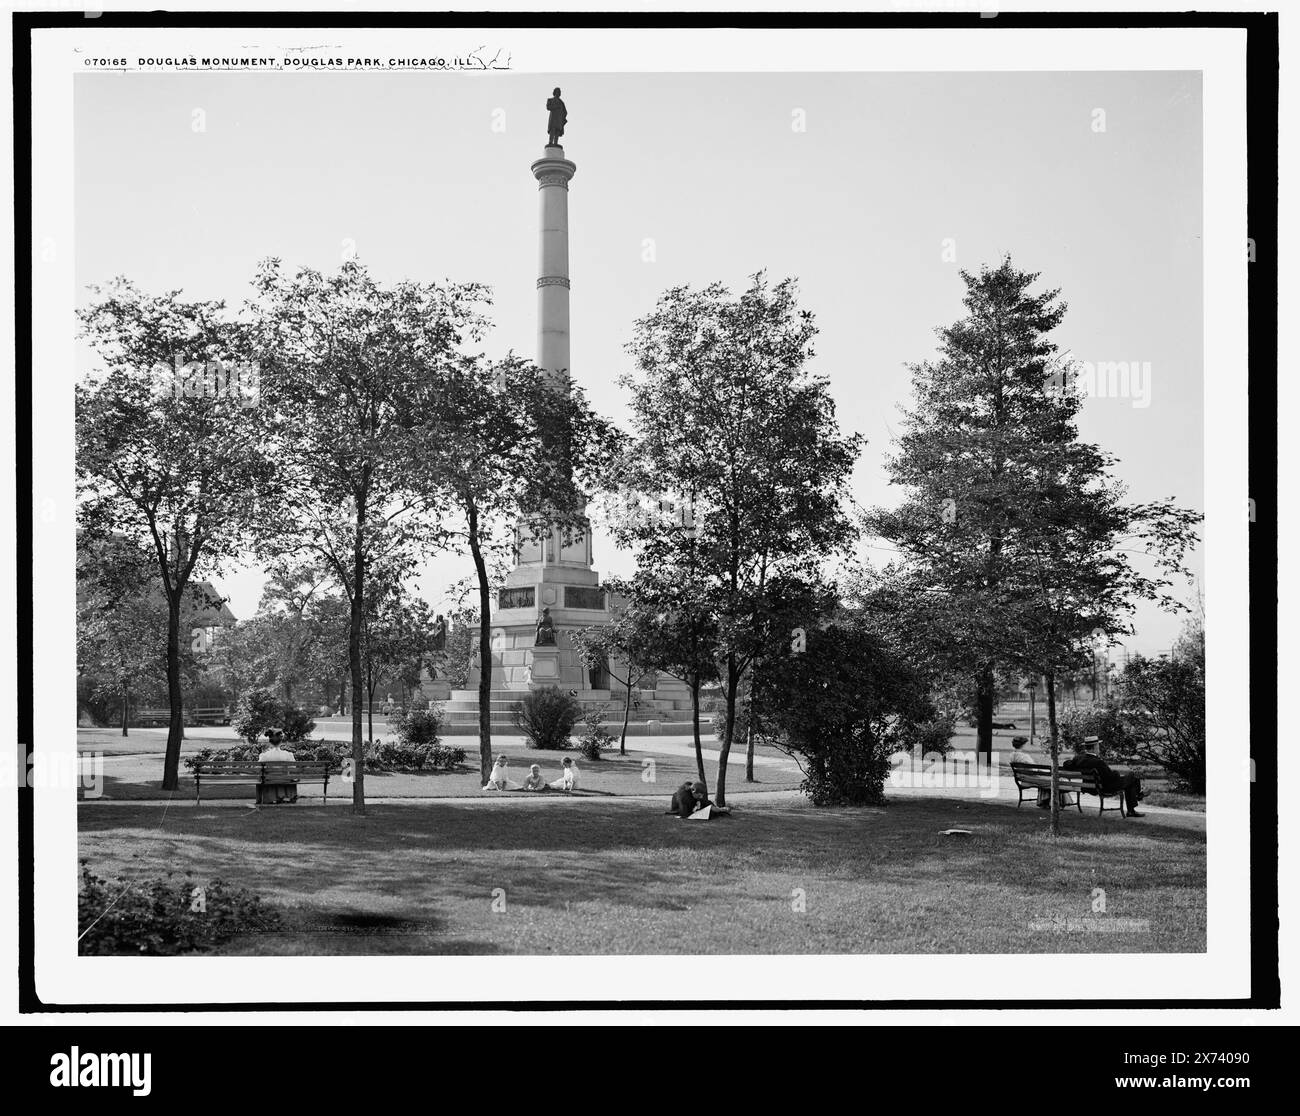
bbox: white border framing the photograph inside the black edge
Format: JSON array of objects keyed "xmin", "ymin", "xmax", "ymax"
[{"xmin": 27, "ymin": 21, "xmax": 1251, "ymax": 1008}]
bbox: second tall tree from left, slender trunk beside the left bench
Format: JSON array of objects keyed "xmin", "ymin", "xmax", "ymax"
[{"xmin": 246, "ymin": 260, "xmax": 486, "ymax": 814}]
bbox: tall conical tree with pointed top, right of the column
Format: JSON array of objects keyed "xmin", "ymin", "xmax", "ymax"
[{"xmin": 868, "ymin": 258, "xmax": 1078, "ymax": 756}]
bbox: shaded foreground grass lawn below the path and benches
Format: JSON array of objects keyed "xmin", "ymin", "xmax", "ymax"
[{"xmin": 79, "ymin": 797, "xmax": 1205, "ymax": 955}]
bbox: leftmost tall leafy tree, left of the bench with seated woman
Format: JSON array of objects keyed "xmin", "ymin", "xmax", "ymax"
[{"xmin": 75, "ymin": 278, "xmax": 272, "ymax": 791}]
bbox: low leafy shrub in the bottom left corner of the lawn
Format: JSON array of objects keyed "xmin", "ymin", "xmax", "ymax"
[{"xmin": 77, "ymin": 861, "xmax": 280, "ymax": 956}]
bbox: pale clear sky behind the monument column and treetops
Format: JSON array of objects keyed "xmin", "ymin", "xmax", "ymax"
[{"xmin": 75, "ymin": 72, "xmax": 1204, "ymax": 652}]
